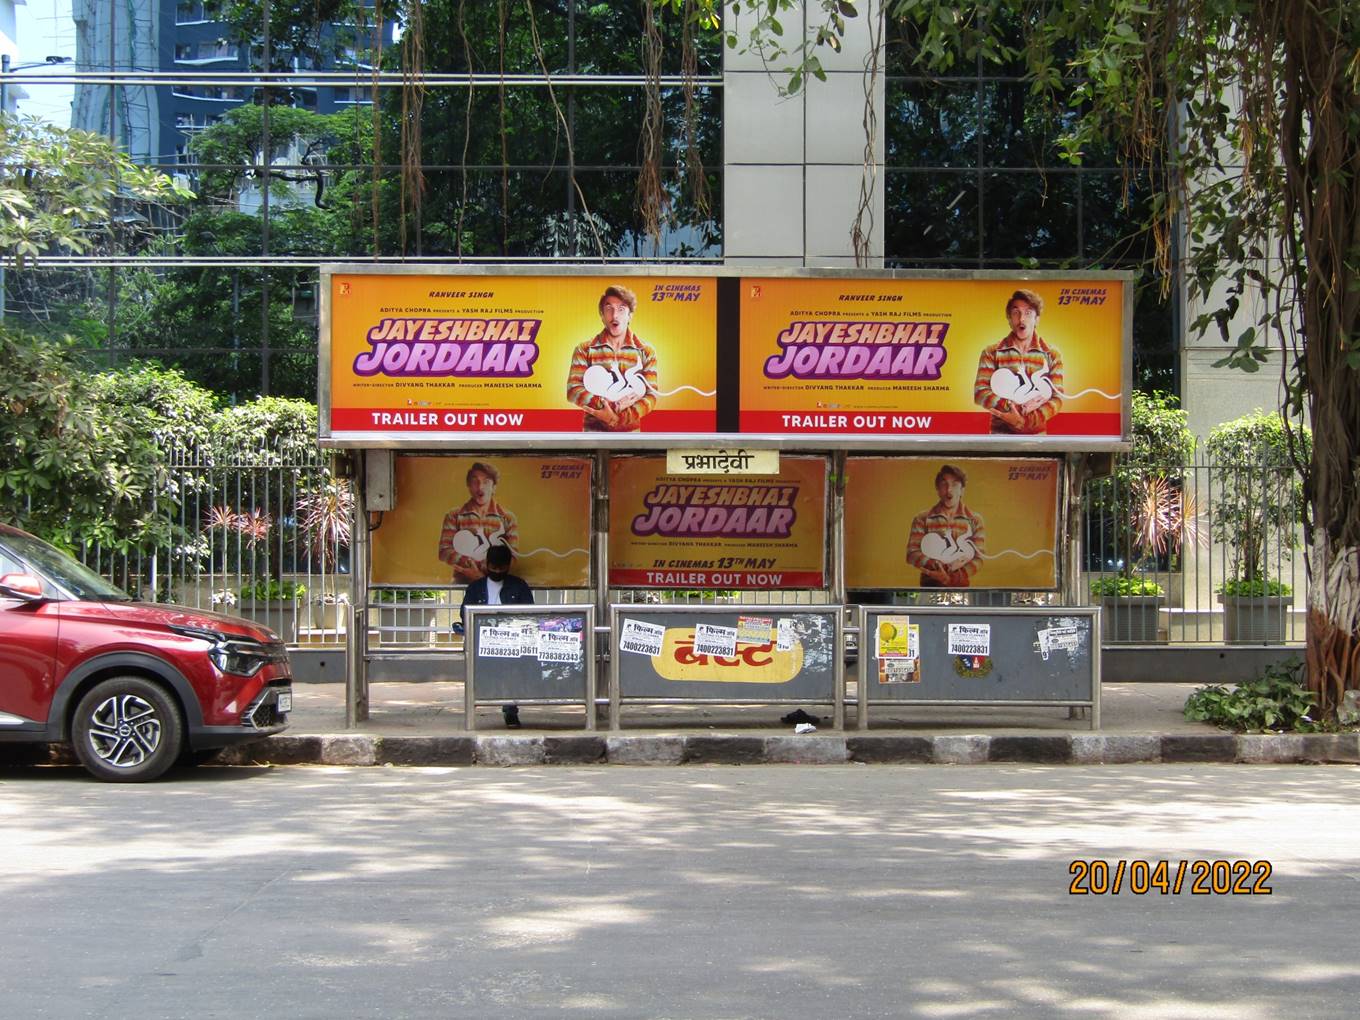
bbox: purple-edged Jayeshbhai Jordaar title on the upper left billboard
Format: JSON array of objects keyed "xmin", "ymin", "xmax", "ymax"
[{"xmin": 354, "ymin": 318, "xmax": 543, "ymax": 378}]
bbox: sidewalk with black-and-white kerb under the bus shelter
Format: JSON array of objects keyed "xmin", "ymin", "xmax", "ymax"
[{"xmin": 209, "ymin": 681, "xmax": 1360, "ymax": 766}]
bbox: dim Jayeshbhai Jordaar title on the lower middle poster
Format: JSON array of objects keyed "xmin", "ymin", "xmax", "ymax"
[{"xmin": 631, "ymin": 483, "xmax": 798, "ymax": 539}]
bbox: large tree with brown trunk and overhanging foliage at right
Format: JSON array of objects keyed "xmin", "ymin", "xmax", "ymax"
[{"xmin": 728, "ymin": 0, "xmax": 1360, "ymax": 713}]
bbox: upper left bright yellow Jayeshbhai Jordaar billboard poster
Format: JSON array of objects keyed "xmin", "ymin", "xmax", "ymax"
[{"xmin": 322, "ymin": 273, "xmax": 717, "ymax": 438}]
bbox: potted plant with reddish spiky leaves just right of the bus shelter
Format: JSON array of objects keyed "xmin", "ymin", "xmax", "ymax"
[{"xmin": 1087, "ymin": 392, "xmax": 1202, "ymax": 643}]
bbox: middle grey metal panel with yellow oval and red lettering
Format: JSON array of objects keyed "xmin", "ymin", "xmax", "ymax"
[{"xmin": 611, "ymin": 605, "xmax": 843, "ymax": 704}]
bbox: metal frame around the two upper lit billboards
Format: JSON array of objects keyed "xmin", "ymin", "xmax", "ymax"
[{"xmin": 317, "ymin": 262, "xmax": 1134, "ymax": 454}]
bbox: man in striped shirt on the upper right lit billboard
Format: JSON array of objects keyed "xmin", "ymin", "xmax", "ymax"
[{"xmin": 972, "ymin": 290, "xmax": 1062, "ymax": 435}]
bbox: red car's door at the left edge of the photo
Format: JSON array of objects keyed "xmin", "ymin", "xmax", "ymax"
[{"xmin": 0, "ymin": 547, "xmax": 61, "ymax": 740}]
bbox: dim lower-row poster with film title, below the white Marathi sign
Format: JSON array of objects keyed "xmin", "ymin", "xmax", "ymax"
[{"xmin": 609, "ymin": 457, "xmax": 827, "ymax": 589}]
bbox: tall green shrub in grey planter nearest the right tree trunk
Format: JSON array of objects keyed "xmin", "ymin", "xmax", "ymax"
[{"xmin": 1208, "ymin": 411, "xmax": 1312, "ymax": 643}]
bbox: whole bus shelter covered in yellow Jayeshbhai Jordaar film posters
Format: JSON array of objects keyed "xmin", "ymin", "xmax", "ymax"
[{"xmin": 320, "ymin": 265, "xmax": 1133, "ymax": 726}]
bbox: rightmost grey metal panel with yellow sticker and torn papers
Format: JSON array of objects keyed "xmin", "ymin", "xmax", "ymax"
[{"xmin": 860, "ymin": 607, "xmax": 1100, "ymax": 704}]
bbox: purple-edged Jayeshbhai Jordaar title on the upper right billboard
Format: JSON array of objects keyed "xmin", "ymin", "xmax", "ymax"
[{"xmin": 764, "ymin": 320, "xmax": 949, "ymax": 379}]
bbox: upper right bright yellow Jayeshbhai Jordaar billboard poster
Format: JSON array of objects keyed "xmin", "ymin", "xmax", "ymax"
[{"xmin": 741, "ymin": 277, "xmax": 1125, "ymax": 439}]
